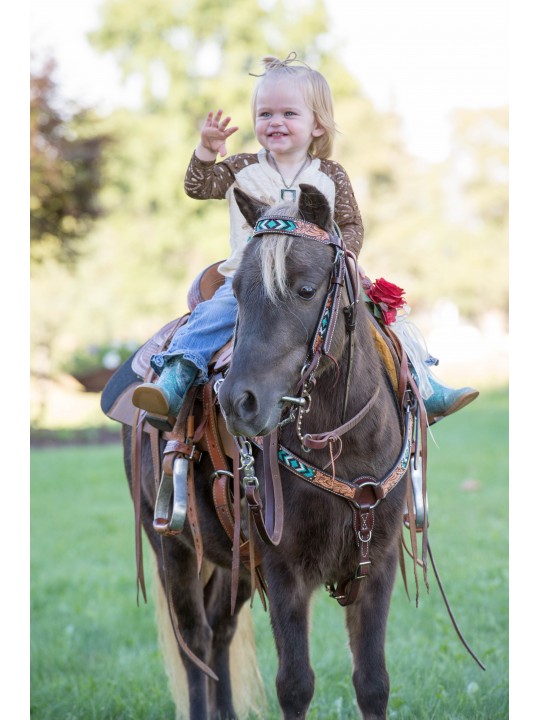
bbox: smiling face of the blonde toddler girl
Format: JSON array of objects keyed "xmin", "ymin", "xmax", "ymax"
[{"xmin": 255, "ymin": 79, "xmax": 324, "ymax": 162}]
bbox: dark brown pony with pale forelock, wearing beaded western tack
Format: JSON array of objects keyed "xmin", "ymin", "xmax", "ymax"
[{"xmin": 124, "ymin": 185, "xmax": 420, "ymax": 720}]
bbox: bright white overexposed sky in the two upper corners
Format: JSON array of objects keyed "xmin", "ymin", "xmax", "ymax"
[{"xmin": 30, "ymin": 0, "xmax": 508, "ymax": 160}]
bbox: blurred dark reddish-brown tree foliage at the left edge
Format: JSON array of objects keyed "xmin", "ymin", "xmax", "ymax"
[{"xmin": 30, "ymin": 58, "xmax": 107, "ymax": 262}]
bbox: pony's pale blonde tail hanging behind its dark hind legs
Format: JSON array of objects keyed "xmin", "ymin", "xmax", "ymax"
[{"xmin": 152, "ymin": 558, "xmax": 267, "ymax": 720}]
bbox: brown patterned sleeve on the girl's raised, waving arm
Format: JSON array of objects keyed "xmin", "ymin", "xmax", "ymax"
[{"xmin": 184, "ymin": 153, "xmax": 258, "ymax": 200}]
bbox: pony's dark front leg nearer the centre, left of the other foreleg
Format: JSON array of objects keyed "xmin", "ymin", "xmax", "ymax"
[{"xmin": 266, "ymin": 565, "xmax": 315, "ymax": 720}]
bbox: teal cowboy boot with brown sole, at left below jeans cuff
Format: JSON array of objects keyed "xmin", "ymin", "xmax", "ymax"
[{"xmin": 132, "ymin": 357, "xmax": 199, "ymax": 431}]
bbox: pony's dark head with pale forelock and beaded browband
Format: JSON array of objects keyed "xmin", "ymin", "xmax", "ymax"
[{"xmin": 219, "ymin": 185, "xmax": 335, "ymax": 437}]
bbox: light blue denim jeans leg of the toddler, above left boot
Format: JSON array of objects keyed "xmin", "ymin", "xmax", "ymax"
[{"xmin": 150, "ymin": 278, "xmax": 238, "ymax": 385}]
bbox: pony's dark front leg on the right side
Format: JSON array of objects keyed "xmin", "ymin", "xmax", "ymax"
[{"xmin": 347, "ymin": 555, "xmax": 397, "ymax": 720}]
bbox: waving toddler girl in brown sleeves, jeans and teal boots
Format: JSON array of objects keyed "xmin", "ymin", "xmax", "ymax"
[{"xmin": 133, "ymin": 53, "xmax": 478, "ymax": 430}]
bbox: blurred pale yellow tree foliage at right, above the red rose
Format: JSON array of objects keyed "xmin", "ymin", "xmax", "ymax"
[{"xmin": 363, "ymin": 108, "xmax": 508, "ymax": 322}]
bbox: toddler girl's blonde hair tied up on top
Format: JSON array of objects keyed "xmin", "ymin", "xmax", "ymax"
[{"xmin": 250, "ymin": 52, "xmax": 337, "ymax": 158}]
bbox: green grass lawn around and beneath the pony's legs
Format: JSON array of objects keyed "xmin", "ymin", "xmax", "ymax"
[{"xmin": 31, "ymin": 390, "xmax": 508, "ymax": 720}]
